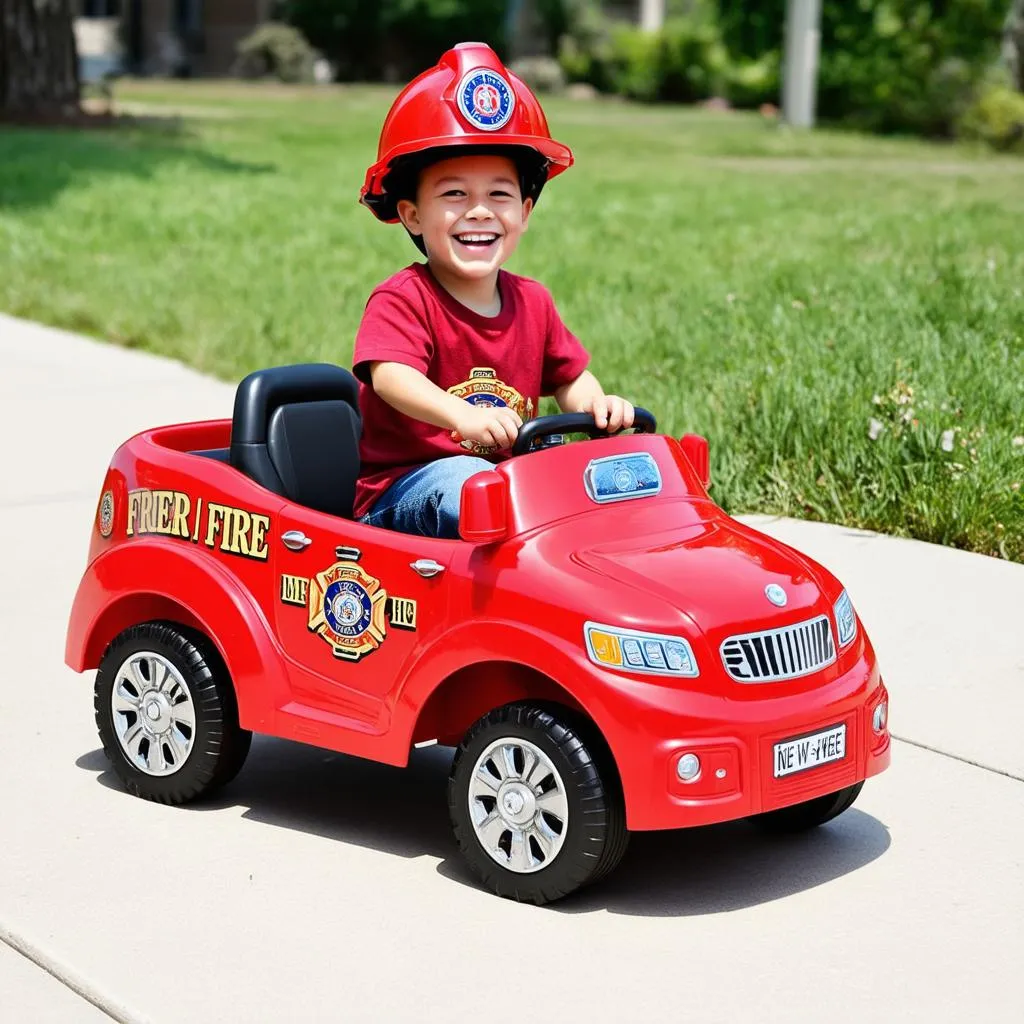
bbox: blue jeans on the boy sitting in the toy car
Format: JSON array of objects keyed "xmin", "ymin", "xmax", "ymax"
[{"xmin": 359, "ymin": 455, "xmax": 495, "ymax": 538}]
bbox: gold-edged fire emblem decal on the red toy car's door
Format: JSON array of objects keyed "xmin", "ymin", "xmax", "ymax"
[{"xmin": 309, "ymin": 562, "xmax": 387, "ymax": 662}]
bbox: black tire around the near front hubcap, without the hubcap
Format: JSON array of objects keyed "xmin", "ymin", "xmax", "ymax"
[{"xmin": 449, "ymin": 703, "xmax": 629, "ymax": 905}]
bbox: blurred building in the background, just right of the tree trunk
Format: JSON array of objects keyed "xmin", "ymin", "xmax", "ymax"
[{"xmin": 72, "ymin": 0, "xmax": 273, "ymax": 78}]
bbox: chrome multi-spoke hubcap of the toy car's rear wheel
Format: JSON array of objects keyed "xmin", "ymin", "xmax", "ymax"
[{"xmin": 111, "ymin": 650, "xmax": 196, "ymax": 775}]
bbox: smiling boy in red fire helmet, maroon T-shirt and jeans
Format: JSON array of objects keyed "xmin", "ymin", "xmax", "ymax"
[{"xmin": 353, "ymin": 43, "xmax": 633, "ymax": 538}]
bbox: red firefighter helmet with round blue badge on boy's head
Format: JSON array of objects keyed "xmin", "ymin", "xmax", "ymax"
[{"xmin": 359, "ymin": 43, "xmax": 572, "ymax": 223}]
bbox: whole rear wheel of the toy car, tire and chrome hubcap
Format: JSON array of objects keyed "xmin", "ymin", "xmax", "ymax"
[{"xmin": 94, "ymin": 623, "xmax": 252, "ymax": 804}]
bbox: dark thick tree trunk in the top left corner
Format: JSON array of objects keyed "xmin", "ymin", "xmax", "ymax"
[{"xmin": 0, "ymin": 0, "xmax": 79, "ymax": 119}]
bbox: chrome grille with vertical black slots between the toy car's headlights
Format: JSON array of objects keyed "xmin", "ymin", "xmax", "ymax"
[{"xmin": 722, "ymin": 615, "xmax": 836, "ymax": 683}]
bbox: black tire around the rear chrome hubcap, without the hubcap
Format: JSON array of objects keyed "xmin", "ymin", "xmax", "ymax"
[{"xmin": 93, "ymin": 623, "xmax": 252, "ymax": 804}]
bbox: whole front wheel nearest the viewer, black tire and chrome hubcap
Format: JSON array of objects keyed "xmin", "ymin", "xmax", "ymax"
[{"xmin": 449, "ymin": 703, "xmax": 629, "ymax": 905}]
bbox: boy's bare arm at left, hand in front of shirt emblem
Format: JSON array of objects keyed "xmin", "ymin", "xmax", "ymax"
[{"xmin": 370, "ymin": 361, "xmax": 522, "ymax": 449}]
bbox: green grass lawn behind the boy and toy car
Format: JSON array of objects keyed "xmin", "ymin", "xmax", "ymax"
[{"xmin": 0, "ymin": 83, "xmax": 1024, "ymax": 561}]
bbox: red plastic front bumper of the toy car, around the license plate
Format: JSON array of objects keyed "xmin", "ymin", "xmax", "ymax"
[{"xmin": 605, "ymin": 647, "xmax": 891, "ymax": 831}]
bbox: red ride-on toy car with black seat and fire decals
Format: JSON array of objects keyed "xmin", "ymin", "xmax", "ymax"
[{"xmin": 67, "ymin": 366, "xmax": 890, "ymax": 903}]
